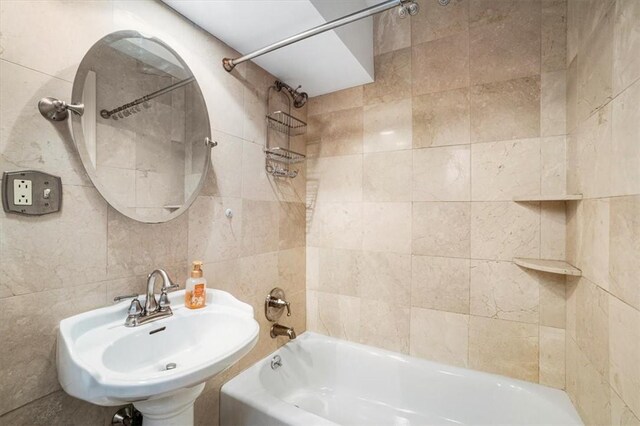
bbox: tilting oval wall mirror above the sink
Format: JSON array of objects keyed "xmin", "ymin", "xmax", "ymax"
[{"xmin": 72, "ymin": 31, "xmax": 211, "ymax": 223}]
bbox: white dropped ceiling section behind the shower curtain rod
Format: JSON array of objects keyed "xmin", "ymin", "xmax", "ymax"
[{"xmin": 162, "ymin": 0, "xmax": 382, "ymax": 96}]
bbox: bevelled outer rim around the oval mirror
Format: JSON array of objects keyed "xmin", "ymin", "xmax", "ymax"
[{"xmin": 70, "ymin": 30, "xmax": 212, "ymax": 223}]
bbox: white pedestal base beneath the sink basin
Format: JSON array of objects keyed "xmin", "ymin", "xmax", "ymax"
[{"xmin": 133, "ymin": 383, "xmax": 204, "ymax": 426}]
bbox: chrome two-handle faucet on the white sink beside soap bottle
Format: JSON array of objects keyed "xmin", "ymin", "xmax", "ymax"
[{"xmin": 113, "ymin": 269, "xmax": 178, "ymax": 327}]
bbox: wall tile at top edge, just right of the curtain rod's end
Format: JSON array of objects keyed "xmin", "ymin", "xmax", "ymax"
[{"xmin": 411, "ymin": 0, "xmax": 469, "ymax": 45}]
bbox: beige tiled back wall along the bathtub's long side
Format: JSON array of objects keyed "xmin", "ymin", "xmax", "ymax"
[{"xmin": 307, "ymin": 0, "xmax": 566, "ymax": 388}]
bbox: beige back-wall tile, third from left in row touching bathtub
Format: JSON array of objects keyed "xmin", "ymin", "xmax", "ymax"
[{"xmin": 409, "ymin": 308, "xmax": 469, "ymax": 367}]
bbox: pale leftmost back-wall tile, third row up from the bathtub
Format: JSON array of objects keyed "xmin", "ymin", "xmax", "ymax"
[{"xmin": 307, "ymin": 203, "xmax": 363, "ymax": 250}]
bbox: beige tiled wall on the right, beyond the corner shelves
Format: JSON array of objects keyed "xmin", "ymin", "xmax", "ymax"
[{"xmin": 566, "ymin": 0, "xmax": 640, "ymax": 425}]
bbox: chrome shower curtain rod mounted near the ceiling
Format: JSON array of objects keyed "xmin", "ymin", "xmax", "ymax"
[{"xmin": 222, "ymin": 0, "xmax": 418, "ymax": 72}]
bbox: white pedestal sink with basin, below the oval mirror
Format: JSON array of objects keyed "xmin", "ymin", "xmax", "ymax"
[{"xmin": 57, "ymin": 289, "xmax": 259, "ymax": 426}]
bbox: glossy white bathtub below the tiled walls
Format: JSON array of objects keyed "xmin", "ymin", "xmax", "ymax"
[{"xmin": 220, "ymin": 332, "xmax": 582, "ymax": 426}]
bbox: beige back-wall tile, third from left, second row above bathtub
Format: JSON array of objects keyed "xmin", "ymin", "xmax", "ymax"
[{"xmin": 411, "ymin": 256, "xmax": 469, "ymax": 314}]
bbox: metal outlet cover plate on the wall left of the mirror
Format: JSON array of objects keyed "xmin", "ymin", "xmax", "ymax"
[{"xmin": 2, "ymin": 170, "xmax": 62, "ymax": 216}]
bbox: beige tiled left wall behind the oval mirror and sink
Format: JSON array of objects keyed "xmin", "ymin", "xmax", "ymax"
[{"xmin": 0, "ymin": 1, "xmax": 306, "ymax": 426}]
